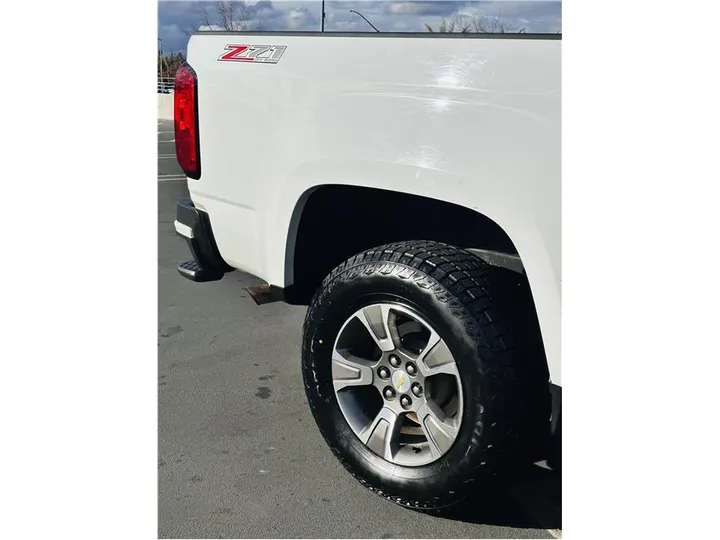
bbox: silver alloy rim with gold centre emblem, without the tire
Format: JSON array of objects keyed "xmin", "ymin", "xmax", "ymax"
[{"xmin": 331, "ymin": 303, "xmax": 463, "ymax": 467}]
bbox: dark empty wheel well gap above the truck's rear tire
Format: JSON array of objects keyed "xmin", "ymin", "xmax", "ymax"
[{"xmin": 285, "ymin": 185, "xmax": 517, "ymax": 304}]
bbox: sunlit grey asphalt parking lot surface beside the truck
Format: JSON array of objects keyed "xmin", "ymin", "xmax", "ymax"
[{"xmin": 158, "ymin": 121, "xmax": 560, "ymax": 538}]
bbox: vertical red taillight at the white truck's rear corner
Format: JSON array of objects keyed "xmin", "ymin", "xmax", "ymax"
[{"xmin": 175, "ymin": 64, "xmax": 200, "ymax": 180}]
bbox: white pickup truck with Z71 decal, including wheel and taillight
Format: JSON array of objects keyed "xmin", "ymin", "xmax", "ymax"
[{"xmin": 174, "ymin": 32, "xmax": 561, "ymax": 509}]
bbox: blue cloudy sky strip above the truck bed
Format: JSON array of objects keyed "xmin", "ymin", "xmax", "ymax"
[{"xmin": 158, "ymin": 0, "xmax": 562, "ymax": 54}]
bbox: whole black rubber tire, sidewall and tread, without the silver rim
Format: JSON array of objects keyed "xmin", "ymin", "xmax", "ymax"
[{"xmin": 302, "ymin": 241, "xmax": 549, "ymax": 509}]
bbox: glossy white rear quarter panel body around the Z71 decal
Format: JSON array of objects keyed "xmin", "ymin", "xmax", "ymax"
[{"xmin": 188, "ymin": 34, "xmax": 561, "ymax": 384}]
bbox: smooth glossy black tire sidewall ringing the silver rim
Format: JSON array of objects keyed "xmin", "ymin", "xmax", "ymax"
[{"xmin": 303, "ymin": 263, "xmax": 493, "ymax": 506}]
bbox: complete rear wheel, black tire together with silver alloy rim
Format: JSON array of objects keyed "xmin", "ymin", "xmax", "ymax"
[{"xmin": 303, "ymin": 241, "xmax": 549, "ymax": 509}]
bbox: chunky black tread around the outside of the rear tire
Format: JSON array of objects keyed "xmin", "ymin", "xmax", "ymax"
[{"xmin": 303, "ymin": 240, "xmax": 547, "ymax": 509}]
